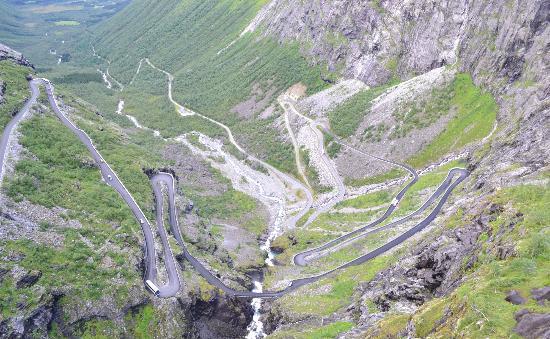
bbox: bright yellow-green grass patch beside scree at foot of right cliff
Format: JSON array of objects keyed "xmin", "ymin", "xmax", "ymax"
[{"xmin": 408, "ymin": 74, "xmax": 498, "ymax": 167}]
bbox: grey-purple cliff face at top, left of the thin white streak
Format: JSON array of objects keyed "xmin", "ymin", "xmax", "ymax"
[{"xmin": 251, "ymin": 0, "xmax": 468, "ymax": 85}]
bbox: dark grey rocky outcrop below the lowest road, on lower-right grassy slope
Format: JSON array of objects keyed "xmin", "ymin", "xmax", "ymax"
[{"xmin": 352, "ymin": 204, "xmax": 504, "ymax": 322}]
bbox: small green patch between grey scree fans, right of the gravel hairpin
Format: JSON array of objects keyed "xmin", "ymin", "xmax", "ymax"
[{"xmin": 328, "ymin": 82, "xmax": 395, "ymax": 138}]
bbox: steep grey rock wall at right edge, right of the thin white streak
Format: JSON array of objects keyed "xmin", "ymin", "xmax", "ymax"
[{"xmin": 460, "ymin": 1, "xmax": 550, "ymax": 173}]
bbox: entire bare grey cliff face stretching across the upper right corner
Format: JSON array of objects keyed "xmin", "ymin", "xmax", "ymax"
[{"xmin": 252, "ymin": 0, "xmax": 550, "ymax": 124}]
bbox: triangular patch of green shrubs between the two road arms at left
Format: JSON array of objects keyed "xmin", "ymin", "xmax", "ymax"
[{"xmin": 7, "ymin": 116, "xmax": 135, "ymax": 225}]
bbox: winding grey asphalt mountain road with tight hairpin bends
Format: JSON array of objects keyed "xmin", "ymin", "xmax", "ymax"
[{"xmin": 0, "ymin": 79, "xmax": 469, "ymax": 298}]
